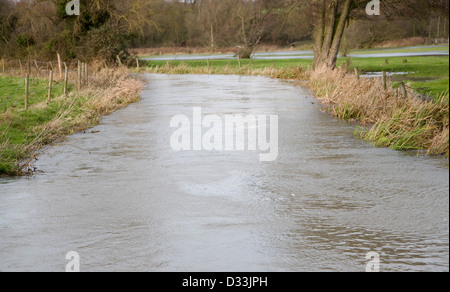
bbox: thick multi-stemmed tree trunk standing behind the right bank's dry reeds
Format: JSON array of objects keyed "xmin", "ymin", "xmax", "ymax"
[{"xmin": 314, "ymin": 0, "xmax": 354, "ymax": 70}]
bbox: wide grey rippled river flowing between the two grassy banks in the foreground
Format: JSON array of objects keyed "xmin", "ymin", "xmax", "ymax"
[{"xmin": 0, "ymin": 75, "xmax": 449, "ymax": 272}]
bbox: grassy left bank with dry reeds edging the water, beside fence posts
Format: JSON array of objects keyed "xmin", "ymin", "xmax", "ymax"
[{"xmin": 0, "ymin": 68, "xmax": 143, "ymax": 175}]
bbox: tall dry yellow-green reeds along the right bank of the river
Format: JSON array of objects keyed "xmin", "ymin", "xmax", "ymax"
[{"xmin": 309, "ymin": 69, "xmax": 449, "ymax": 156}]
